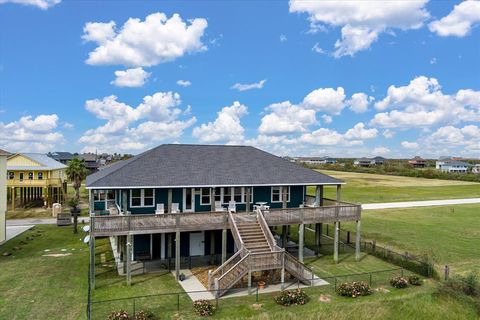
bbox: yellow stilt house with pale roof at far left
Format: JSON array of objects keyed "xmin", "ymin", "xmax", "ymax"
[{"xmin": 7, "ymin": 153, "xmax": 67, "ymax": 211}]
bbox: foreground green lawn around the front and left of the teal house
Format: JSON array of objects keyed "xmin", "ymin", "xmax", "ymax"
[{"xmin": 0, "ymin": 226, "xmax": 476, "ymax": 319}]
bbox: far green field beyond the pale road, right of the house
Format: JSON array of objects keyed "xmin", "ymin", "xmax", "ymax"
[{"xmin": 314, "ymin": 170, "xmax": 480, "ymax": 203}]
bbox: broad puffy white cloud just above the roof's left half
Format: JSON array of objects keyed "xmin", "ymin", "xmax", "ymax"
[{"xmin": 79, "ymin": 92, "xmax": 196, "ymax": 152}]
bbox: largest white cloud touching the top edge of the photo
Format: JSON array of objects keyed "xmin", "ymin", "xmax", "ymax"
[{"xmin": 290, "ymin": 0, "xmax": 430, "ymax": 58}]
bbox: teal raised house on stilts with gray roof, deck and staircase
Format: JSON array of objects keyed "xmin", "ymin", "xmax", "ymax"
[{"xmin": 87, "ymin": 144, "xmax": 361, "ymax": 295}]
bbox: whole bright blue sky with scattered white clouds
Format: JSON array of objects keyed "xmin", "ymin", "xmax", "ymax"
[{"xmin": 0, "ymin": 0, "xmax": 480, "ymax": 157}]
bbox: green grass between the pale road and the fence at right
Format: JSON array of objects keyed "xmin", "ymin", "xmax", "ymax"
[{"xmin": 342, "ymin": 204, "xmax": 480, "ymax": 273}]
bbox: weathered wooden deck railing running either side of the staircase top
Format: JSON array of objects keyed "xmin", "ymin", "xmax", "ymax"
[{"xmin": 91, "ymin": 202, "xmax": 361, "ymax": 237}]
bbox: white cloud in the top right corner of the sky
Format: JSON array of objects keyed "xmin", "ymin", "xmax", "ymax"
[{"xmin": 428, "ymin": 0, "xmax": 480, "ymax": 37}]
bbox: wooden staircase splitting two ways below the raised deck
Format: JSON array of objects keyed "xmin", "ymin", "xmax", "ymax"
[{"xmin": 208, "ymin": 210, "xmax": 318, "ymax": 298}]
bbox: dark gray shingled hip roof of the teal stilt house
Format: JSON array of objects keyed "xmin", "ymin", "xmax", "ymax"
[{"xmin": 87, "ymin": 144, "xmax": 343, "ymax": 188}]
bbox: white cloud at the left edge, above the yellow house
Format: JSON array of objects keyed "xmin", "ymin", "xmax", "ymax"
[{"xmin": 0, "ymin": 114, "xmax": 64, "ymax": 152}]
